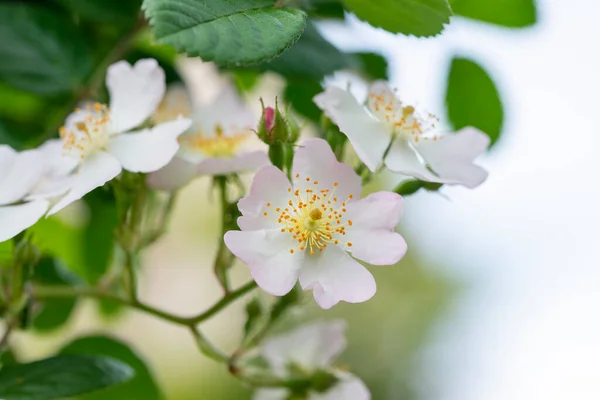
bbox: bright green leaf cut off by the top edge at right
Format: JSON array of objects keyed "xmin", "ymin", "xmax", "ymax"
[{"xmin": 452, "ymin": 0, "xmax": 537, "ymax": 28}]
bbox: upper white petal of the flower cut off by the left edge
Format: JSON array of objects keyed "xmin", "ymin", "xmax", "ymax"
[{"xmin": 0, "ymin": 149, "xmax": 46, "ymax": 205}]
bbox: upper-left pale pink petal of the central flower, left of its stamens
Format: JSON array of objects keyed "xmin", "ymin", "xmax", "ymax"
[{"xmin": 238, "ymin": 165, "xmax": 291, "ymax": 231}]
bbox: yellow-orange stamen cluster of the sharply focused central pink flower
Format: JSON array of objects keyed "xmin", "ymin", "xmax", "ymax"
[{"xmin": 263, "ymin": 174, "xmax": 352, "ymax": 255}]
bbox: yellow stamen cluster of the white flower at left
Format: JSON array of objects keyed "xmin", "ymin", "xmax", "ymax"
[{"xmin": 59, "ymin": 103, "xmax": 115, "ymax": 160}]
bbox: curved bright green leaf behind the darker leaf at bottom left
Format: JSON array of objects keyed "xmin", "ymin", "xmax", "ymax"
[{"xmin": 60, "ymin": 336, "xmax": 162, "ymax": 400}]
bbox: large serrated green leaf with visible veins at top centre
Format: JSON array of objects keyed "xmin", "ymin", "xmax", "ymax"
[{"xmin": 143, "ymin": 0, "xmax": 306, "ymax": 66}]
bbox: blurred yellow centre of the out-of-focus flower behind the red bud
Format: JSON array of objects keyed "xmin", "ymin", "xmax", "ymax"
[{"xmin": 179, "ymin": 125, "xmax": 248, "ymax": 158}]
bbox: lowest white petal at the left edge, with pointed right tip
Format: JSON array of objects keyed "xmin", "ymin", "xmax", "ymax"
[{"xmin": 0, "ymin": 200, "xmax": 50, "ymax": 242}]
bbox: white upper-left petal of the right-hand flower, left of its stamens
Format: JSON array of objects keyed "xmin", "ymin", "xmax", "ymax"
[{"xmin": 313, "ymin": 86, "xmax": 391, "ymax": 171}]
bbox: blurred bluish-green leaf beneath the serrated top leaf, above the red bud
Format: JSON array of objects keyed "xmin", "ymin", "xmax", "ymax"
[{"xmin": 261, "ymin": 22, "xmax": 358, "ymax": 80}]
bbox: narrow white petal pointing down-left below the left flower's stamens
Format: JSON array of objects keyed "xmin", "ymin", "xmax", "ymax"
[{"xmin": 48, "ymin": 151, "xmax": 121, "ymax": 215}]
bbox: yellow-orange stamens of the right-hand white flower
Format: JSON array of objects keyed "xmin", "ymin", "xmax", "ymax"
[{"xmin": 367, "ymin": 92, "xmax": 438, "ymax": 142}]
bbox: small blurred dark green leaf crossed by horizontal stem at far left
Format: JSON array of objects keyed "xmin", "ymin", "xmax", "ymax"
[{"xmin": 33, "ymin": 258, "xmax": 82, "ymax": 331}]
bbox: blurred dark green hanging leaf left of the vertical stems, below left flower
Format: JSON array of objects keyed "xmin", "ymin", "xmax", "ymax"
[{"xmin": 83, "ymin": 188, "xmax": 119, "ymax": 284}]
